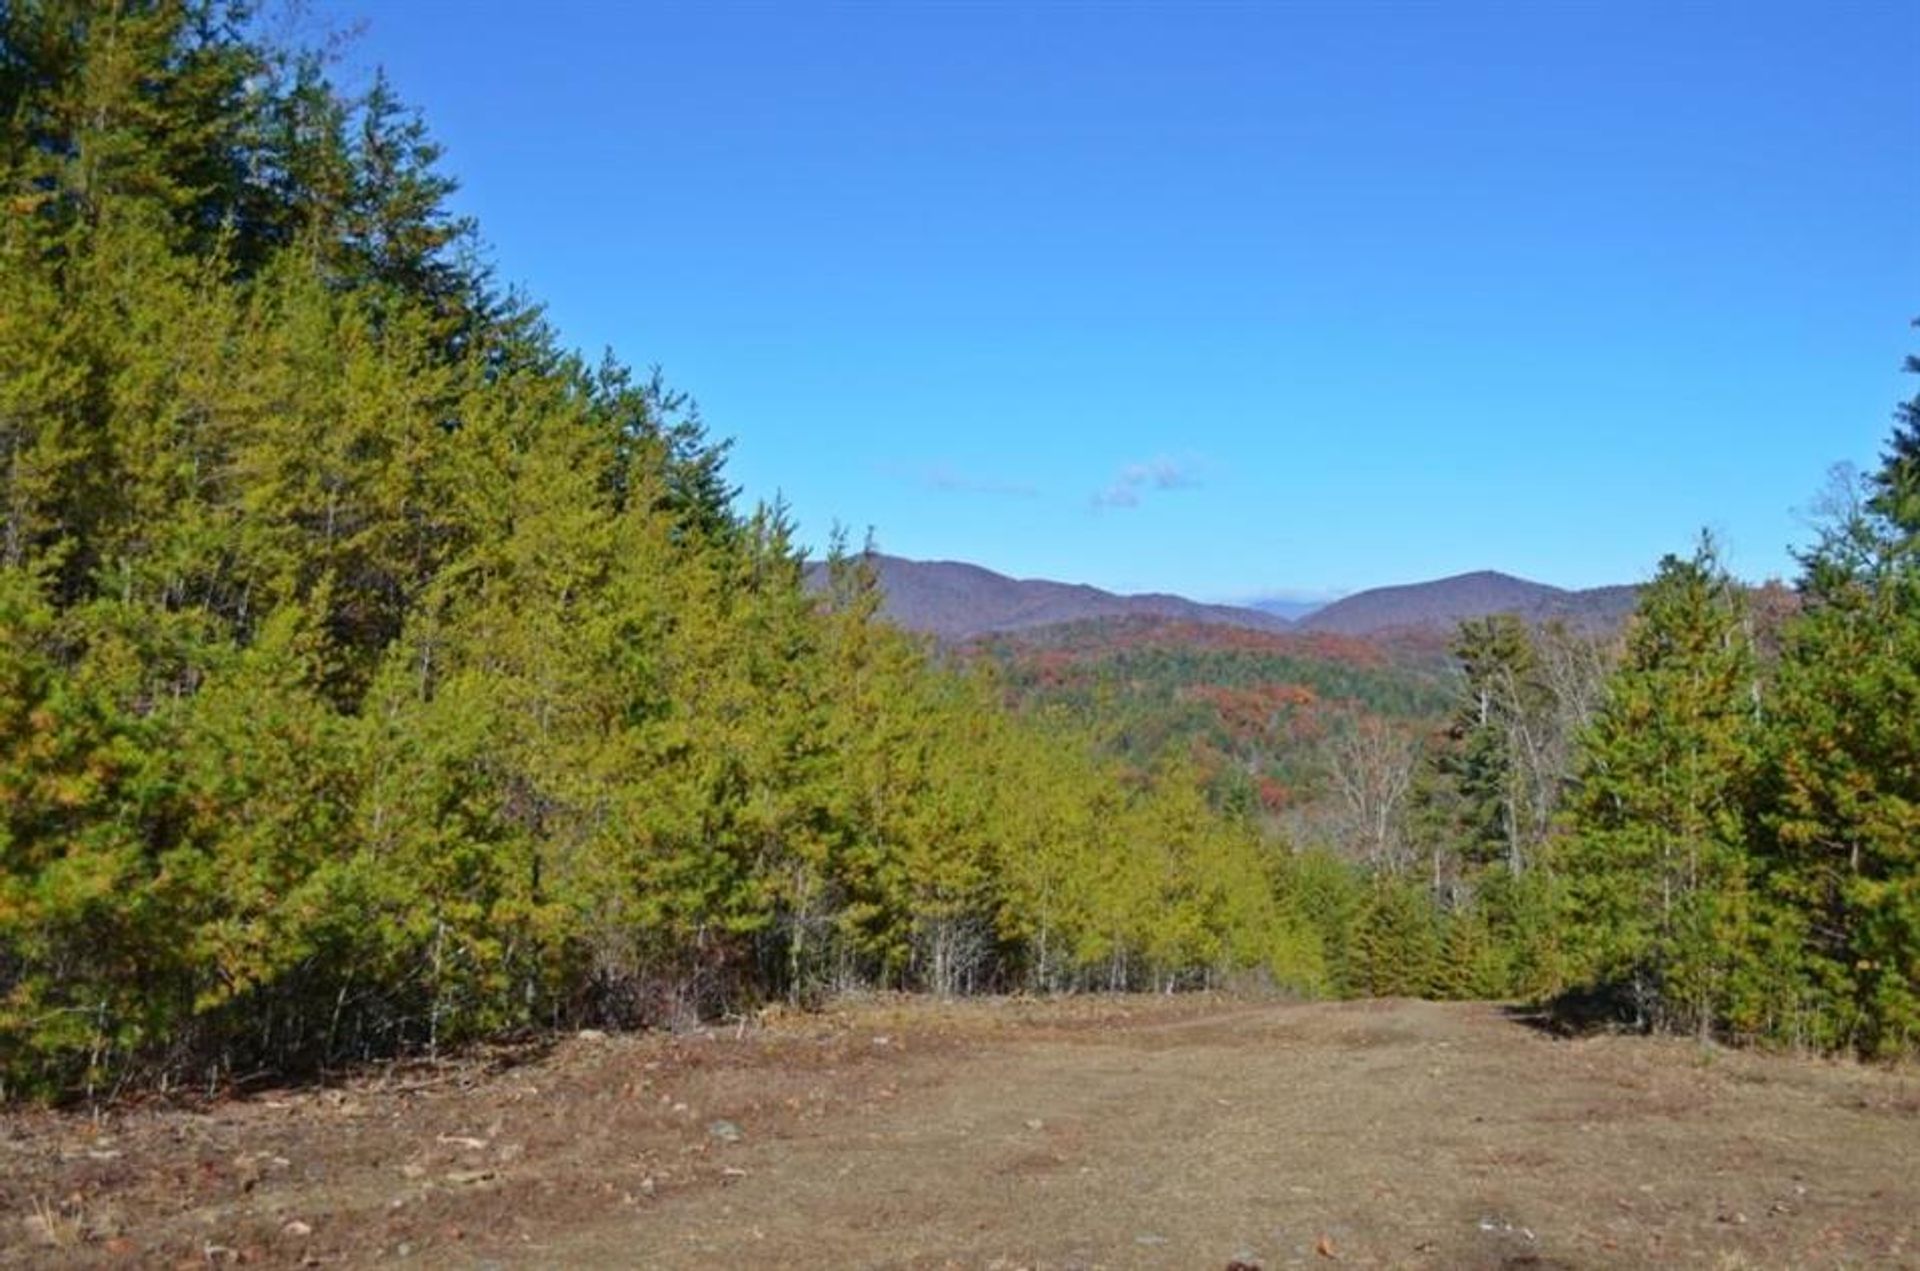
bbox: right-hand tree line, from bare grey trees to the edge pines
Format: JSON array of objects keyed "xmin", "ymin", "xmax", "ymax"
[{"xmin": 1323, "ymin": 393, "xmax": 1920, "ymax": 1056}]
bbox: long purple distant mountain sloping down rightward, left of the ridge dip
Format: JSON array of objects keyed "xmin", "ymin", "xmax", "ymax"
[{"xmin": 810, "ymin": 555, "xmax": 1292, "ymax": 639}]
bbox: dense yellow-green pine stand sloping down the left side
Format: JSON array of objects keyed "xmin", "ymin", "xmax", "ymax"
[{"xmin": 0, "ymin": 0, "xmax": 1321, "ymax": 1094}]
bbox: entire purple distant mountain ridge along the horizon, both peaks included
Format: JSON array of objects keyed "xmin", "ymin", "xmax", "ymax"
[{"xmin": 808, "ymin": 553, "xmax": 1638, "ymax": 641}]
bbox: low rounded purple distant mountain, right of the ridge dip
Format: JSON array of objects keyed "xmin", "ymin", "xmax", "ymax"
[{"xmin": 1300, "ymin": 570, "xmax": 1640, "ymax": 636}]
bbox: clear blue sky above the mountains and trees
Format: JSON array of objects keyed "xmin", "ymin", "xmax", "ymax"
[{"xmin": 319, "ymin": 0, "xmax": 1920, "ymax": 599}]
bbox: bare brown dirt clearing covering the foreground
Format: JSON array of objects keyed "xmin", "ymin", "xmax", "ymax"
[{"xmin": 0, "ymin": 996, "xmax": 1920, "ymax": 1269}]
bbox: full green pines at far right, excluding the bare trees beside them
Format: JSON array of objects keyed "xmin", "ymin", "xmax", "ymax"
[{"xmin": 1567, "ymin": 335, "xmax": 1920, "ymax": 1056}]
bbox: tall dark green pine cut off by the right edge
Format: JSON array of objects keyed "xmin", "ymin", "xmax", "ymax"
[{"xmin": 1763, "ymin": 335, "xmax": 1920, "ymax": 1054}]
